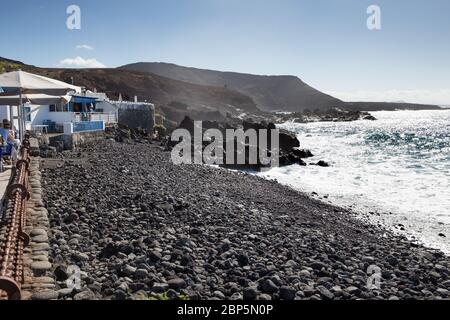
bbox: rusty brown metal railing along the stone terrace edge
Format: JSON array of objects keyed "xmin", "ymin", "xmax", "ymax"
[{"xmin": 0, "ymin": 134, "xmax": 31, "ymax": 300}]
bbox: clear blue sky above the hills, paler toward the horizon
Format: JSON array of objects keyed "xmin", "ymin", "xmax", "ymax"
[{"xmin": 0, "ymin": 0, "xmax": 450, "ymax": 104}]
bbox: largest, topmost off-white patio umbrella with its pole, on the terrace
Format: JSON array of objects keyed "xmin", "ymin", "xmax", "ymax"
[{"xmin": 0, "ymin": 70, "xmax": 81, "ymax": 139}]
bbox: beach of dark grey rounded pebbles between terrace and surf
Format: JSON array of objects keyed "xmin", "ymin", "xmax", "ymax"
[{"xmin": 41, "ymin": 139, "xmax": 450, "ymax": 300}]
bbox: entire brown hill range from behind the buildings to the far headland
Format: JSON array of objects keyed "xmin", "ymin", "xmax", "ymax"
[{"xmin": 0, "ymin": 57, "xmax": 441, "ymax": 115}]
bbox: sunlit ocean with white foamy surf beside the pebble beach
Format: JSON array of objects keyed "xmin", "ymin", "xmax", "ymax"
[{"xmin": 259, "ymin": 110, "xmax": 450, "ymax": 254}]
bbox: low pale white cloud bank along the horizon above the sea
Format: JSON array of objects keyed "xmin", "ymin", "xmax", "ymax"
[{"xmin": 327, "ymin": 89, "xmax": 450, "ymax": 105}]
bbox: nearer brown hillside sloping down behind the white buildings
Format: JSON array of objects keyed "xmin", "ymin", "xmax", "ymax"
[{"xmin": 0, "ymin": 58, "xmax": 258, "ymax": 116}]
